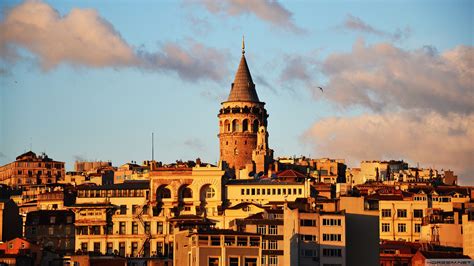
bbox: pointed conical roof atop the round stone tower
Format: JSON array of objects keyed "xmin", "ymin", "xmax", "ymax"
[{"xmin": 227, "ymin": 47, "xmax": 260, "ymax": 102}]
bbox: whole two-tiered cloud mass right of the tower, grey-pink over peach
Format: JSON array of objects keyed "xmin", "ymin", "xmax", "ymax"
[{"xmin": 292, "ymin": 40, "xmax": 474, "ymax": 181}]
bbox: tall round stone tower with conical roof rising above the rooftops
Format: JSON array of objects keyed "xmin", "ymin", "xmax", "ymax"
[{"xmin": 218, "ymin": 39, "xmax": 273, "ymax": 172}]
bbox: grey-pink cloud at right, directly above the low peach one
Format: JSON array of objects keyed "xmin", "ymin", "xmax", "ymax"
[{"xmin": 322, "ymin": 40, "xmax": 474, "ymax": 114}]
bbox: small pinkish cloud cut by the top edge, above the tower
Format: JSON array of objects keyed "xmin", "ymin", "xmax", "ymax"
[{"xmin": 200, "ymin": 0, "xmax": 303, "ymax": 32}]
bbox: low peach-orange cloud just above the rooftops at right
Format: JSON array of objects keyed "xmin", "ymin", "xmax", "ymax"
[{"xmin": 302, "ymin": 111, "xmax": 474, "ymax": 183}]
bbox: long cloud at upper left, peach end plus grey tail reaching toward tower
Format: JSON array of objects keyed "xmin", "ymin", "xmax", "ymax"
[{"xmin": 0, "ymin": 1, "xmax": 227, "ymax": 81}]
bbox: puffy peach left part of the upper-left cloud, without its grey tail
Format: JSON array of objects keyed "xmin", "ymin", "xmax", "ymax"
[{"xmin": 0, "ymin": 1, "xmax": 135, "ymax": 69}]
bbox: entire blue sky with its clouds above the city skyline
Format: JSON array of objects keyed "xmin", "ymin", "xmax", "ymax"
[{"xmin": 0, "ymin": 0, "xmax": 474, "ymax": 185}]
